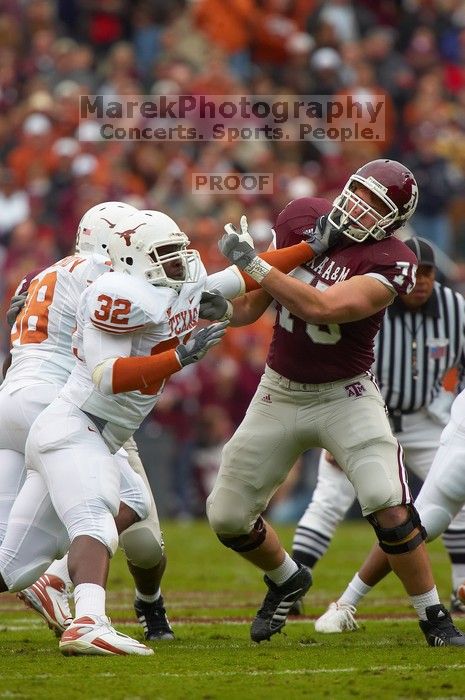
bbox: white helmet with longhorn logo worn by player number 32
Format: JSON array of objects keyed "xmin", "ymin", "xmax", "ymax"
[{"xmin": 108, "ymin": 209, "xmax": 200, "ymax": 291}]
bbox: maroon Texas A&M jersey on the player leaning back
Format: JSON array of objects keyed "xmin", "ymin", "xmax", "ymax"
[{"xmin": 267, "ymin": 197, "xmax": 417, "ymax": 384}]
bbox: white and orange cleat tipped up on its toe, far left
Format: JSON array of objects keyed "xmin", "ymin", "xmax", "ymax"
[{"xmin": 18, "ymin": 574, "xmax": 73, "ymax": 637}]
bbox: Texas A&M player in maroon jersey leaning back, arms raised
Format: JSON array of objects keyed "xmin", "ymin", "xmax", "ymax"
[{"xmin": 207, "ymin": 159, "xmax": 465, "ymax": 646}]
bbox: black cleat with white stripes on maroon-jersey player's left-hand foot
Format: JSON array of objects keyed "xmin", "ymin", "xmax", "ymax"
[{"xmin": 250, "ymin": 564, "xmax": 312, "ymax": 642}]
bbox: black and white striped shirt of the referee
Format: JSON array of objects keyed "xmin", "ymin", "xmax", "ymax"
[{"xmin": 372, "ymin": 282, "xmax": 465, "ymax": 413}]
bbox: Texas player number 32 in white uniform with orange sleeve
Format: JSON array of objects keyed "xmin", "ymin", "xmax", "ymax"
[{"xmin": 0, "ymin": 212, "xmax": 227, "ymax": 654}]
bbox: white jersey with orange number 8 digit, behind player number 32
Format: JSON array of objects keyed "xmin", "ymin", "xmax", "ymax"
[{"xmin": 4, "ymin": 255, "xmax": 110, "ymax": 388}]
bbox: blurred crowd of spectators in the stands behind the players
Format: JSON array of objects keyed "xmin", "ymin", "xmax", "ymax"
[{"xmin": 0, "ymin": 0, "xmax": 465, "ymax": 517}]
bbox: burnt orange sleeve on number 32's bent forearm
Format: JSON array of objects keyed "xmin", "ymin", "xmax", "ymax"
[{"xmin": 112, "ymin": 350, "xmax": 181, "ymax": 394}]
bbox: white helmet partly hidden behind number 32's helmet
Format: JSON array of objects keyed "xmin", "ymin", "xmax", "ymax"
[{"xmin": 75, "ymin": 202, "xmax": 137, "ymax": 257}]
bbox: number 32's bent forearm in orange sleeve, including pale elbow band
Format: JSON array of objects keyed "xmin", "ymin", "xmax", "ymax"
[{"xmin": 92, "ymin": 350, "xmax": 181, "ymax": 394}]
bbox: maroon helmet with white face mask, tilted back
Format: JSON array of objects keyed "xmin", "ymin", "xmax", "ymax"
[{"xmin": 328, "ymin": 158, "xmax": 418, "ymax": 243}]
